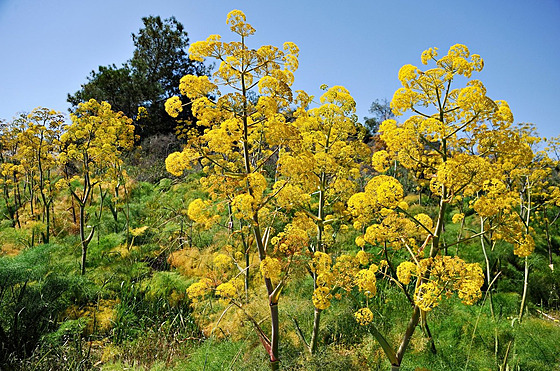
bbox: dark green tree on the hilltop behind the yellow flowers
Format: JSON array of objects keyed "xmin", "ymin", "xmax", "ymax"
[{"xmin": 68, "ymin": 16, "xmax": 208, "ymax": 138}]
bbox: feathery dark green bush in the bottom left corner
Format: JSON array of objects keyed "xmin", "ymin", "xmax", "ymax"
[{"xmin": 0, "ymin": 244, "xmax": 87, "ymax": 364}]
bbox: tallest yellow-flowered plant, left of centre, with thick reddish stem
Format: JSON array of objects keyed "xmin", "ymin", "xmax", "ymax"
[{"xmin": 166, "ymin": 10, "xmax": 298, "ymax": 368}]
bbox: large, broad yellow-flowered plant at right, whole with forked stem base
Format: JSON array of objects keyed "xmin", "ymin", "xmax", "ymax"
[{"xmin": 348, "ymin": 44, "xmax": 534, "ymax": 369}]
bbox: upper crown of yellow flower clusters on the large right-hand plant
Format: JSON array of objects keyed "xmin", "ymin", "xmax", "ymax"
[{"xmin": 380, "ymin": 44, "xmax": 523, "ymax": 203}]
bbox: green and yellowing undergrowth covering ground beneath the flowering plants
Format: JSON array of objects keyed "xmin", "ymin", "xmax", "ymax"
[{"xmin": 0, "ymin": 174, "xmax": 560, "ymax": 370}]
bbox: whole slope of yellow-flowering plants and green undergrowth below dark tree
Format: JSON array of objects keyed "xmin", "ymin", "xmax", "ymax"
[{"xmin": 0, "ymin": 10, "xmax": 560, "ymax": 370}]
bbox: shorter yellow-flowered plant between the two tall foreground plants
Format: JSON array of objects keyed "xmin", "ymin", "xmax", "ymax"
[{"xmin": 272, "ymin": 86, "xmax": 370, "ymax": 353}]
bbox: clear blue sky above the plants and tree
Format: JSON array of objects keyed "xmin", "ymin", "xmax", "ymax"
[{"xmin": 0, "ymin": 0, "xmax": 560, "ymax": 137}]
